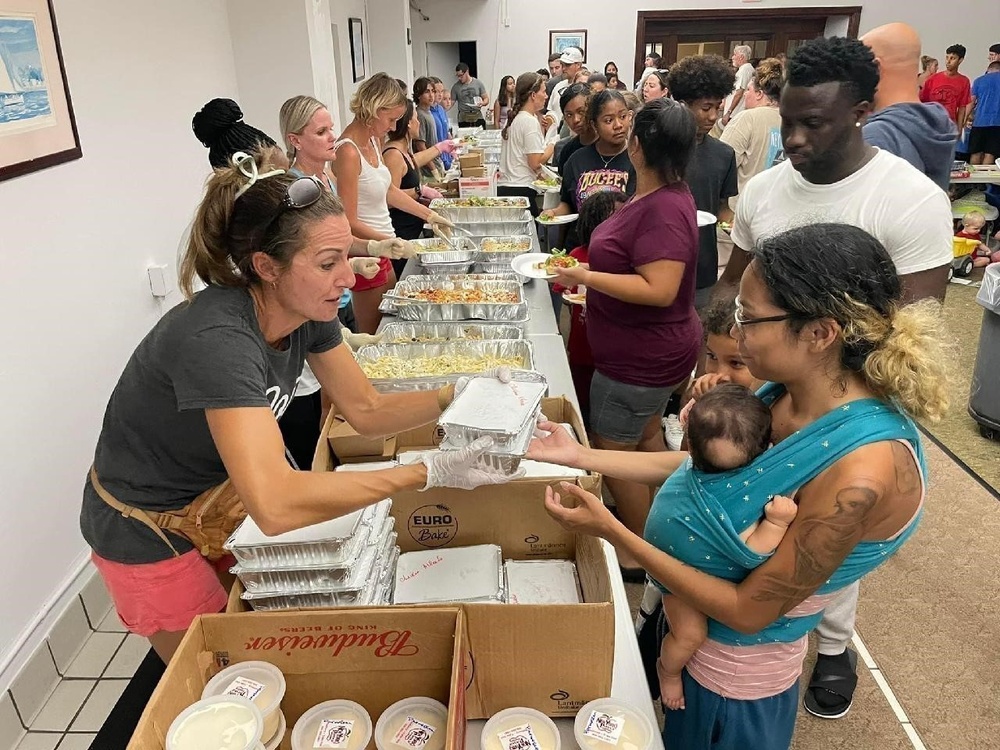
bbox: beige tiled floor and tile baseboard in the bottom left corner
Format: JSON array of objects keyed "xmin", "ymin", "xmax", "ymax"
[{"xmin": 0, "ymin": 579, "xmax": 149, "ymax": 750}]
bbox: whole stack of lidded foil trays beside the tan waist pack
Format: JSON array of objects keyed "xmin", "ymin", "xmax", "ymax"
[{"xmin": 225, "ymin": 500, "xmax": 399, "ymax": 611}]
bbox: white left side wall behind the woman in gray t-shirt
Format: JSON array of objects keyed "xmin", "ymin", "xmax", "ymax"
[{"xmin": 0, "ymin": 0, "xmax": 238, "ymax": 670}]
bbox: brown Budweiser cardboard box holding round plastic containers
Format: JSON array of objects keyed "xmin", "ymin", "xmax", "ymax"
[{"xmin": 128, "ymin": 607, "xmax": 468, "ymax": 750}]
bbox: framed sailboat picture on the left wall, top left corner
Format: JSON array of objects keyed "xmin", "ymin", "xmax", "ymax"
[{"xmin": 0, "ymin": 0, "xmax": 83, "ymax": 181}]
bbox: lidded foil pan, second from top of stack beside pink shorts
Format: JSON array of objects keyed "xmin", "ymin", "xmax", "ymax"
[{"xmin": 229, "ymin": 518, "xmax": 396, "ymax": 596}]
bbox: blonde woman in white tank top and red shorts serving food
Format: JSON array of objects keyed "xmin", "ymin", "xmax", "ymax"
[{"xmin": 332, "ymin": 73, "xmax": 452, "ymax": 334}]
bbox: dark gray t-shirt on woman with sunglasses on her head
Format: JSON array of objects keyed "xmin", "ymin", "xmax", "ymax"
[{"xmin": 80, "ymin": 286, "xmax": 341, "ymax": 564}]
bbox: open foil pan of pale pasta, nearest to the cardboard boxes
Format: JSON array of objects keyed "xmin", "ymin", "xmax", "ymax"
[{"xmin": 354, "ymin": 339, "xmax": 534, "ymax": 393}]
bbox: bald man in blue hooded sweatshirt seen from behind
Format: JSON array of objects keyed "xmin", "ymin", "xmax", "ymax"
[{"xmin": 861, "ymin": 23, "xmax": 957, "ymax": 190}]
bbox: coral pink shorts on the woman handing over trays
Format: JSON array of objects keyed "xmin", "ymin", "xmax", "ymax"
[{"xmin": 90, "ymin": 550, "xmax": 235, "ymax": 638}]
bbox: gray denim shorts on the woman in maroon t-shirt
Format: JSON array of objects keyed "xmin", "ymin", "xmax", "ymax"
[{"xmin": 590, "ymin": 372, "xmax": 680, "ymax": 444}]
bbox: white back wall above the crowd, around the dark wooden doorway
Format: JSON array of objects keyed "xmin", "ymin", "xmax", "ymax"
[{"xmin": 411, "ymin": 0, "xmax": 1000, "ymax": 104}]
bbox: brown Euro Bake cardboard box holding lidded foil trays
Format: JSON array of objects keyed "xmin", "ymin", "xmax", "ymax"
[{"xmin": 282, "ymin": 397, "xmax": 615, "ymax": 719}]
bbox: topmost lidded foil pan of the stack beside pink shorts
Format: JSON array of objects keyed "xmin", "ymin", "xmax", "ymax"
[{"xmin": 224, "ymin": 509, "xmax": 371, "ymax": 570}]
